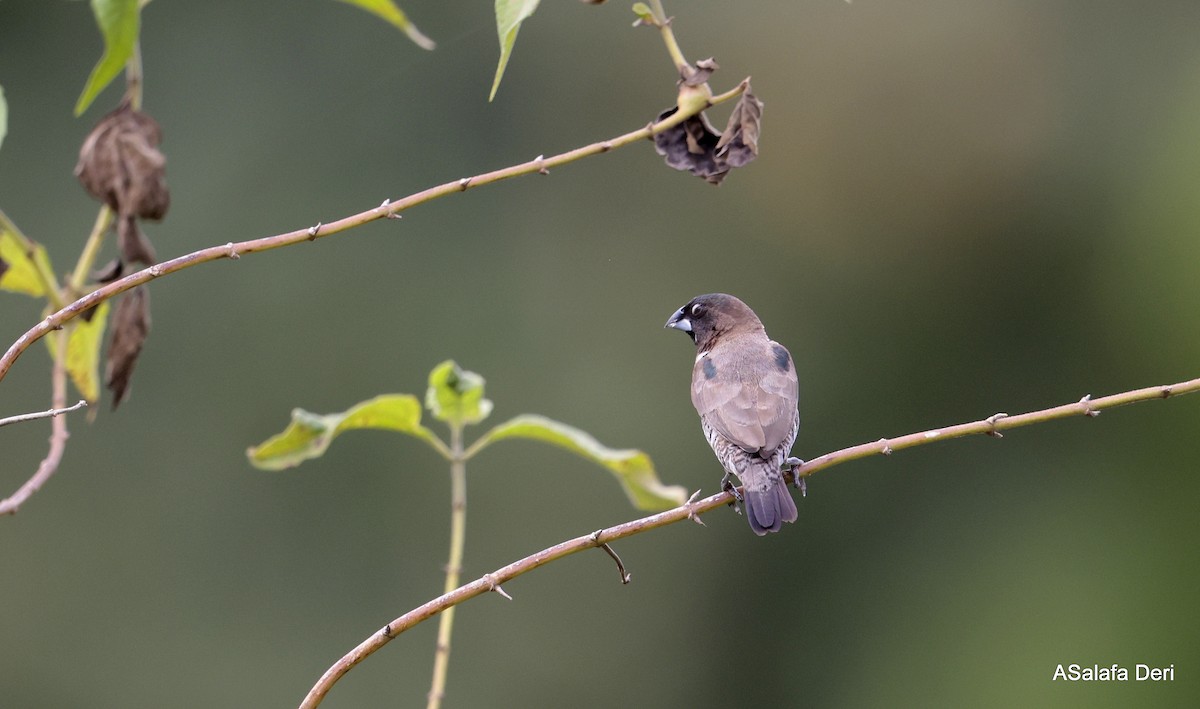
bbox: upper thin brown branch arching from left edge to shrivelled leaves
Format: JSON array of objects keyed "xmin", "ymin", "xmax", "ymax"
[{"xmin": 0, "ymin": 82, "xmax": 748, "ymax": 393}]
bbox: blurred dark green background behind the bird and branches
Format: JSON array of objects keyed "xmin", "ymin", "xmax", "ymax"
[{"xmin": 0, "ymin": 0, "xmax": 1200, "ymax": 708}]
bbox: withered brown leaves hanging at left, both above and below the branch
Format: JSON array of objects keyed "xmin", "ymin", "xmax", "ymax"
[{"xmin": 76, "ymin": 101, "xmax": 170, "ymax": 409}]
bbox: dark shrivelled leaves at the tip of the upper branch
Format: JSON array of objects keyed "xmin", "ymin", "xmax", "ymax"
[{"xmin": 654, "ymin": 80, "xmax": 762, "ymax": 185}]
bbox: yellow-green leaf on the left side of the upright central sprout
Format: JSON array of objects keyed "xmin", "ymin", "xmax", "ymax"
[{"xmin": 246, "ymin": 393, "xmax": 445, "ymax": 470}]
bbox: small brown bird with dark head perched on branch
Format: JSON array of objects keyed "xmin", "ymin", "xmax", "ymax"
[{"xmin": 666, "ymin": 293, "xmax": 800, "ymax": 536}]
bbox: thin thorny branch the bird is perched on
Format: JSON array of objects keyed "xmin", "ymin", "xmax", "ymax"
[{"xmin": 300, "ymin": 378, "xmax": 1200, "ymax": 709}]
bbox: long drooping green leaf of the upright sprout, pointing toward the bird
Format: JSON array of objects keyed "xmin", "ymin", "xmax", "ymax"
[{"xmin": 469, "ymin": 414, "xmax": 688, "ymax": 510}]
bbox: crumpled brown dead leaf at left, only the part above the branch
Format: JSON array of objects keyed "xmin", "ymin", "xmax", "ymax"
[{"xmin": 76, "ymin": 101, "xmax": 170, "ymax": 265}]
